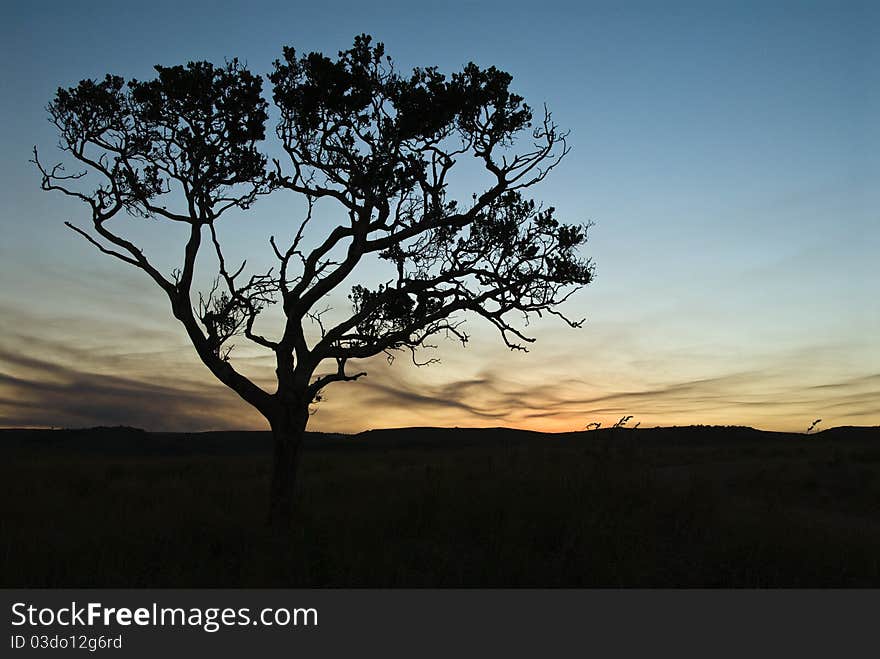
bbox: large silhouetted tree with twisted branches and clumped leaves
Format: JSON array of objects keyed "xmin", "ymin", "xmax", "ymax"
[{"xmin": 34, "ymin": 35, "xmax": 593, "ymax": 522}]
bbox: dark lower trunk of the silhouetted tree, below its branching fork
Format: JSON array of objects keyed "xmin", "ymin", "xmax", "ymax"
[{"xmin": 269, "ymin": 408, "xmax": 309, "ymax": 529}]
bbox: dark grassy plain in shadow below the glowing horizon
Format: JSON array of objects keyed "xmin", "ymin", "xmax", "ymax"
[{"xmin": 0, "ymin": 428, "xmax": 880, "ymax": 587}]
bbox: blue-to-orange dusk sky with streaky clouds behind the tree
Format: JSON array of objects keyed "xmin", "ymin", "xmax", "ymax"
[{"xmin": 0, "ymin": 1, "xmax": 880, "ymax": 432}]
